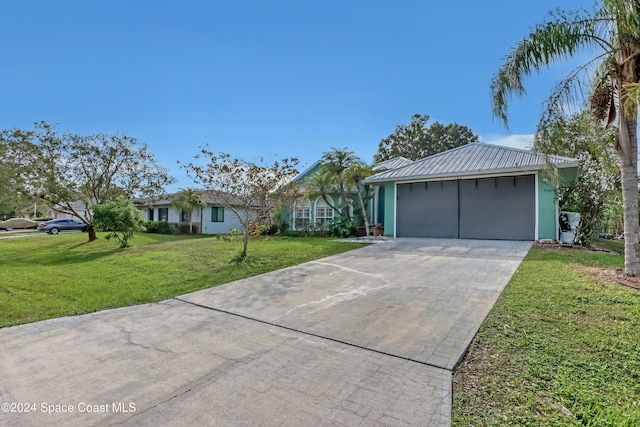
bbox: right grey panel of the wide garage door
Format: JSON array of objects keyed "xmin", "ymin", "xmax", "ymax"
[{"xmin": 460, "ymin": 175, "xmax": 535, "ymax": 240}]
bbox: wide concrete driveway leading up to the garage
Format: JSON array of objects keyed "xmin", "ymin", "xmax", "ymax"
[{"xmin": 0, "ymin": 239, "xmax": 531, "ymax": 426}]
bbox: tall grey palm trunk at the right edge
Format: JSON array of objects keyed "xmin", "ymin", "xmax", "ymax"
[{"xmin": 618, "ymin": 112, "xmax": 640, "ymax": 274}]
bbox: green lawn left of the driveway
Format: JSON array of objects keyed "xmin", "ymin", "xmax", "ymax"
[{"xmin": 0, "ymin": 233, "xmax": 361, "ymax": 327}]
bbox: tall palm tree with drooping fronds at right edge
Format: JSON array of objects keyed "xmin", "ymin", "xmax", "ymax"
[{"xmin": 491, "ymin": 0, "xmax": 640, "ymax": 274}]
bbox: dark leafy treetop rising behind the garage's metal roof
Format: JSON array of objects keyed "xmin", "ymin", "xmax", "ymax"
[{"xmin": 373, "ymin": 114, "xmax": 478, "ymax": 163}]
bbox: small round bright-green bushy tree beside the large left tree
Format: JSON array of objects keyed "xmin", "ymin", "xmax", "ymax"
[{"xmin": 93, "ymin": 197, "xmax": 147, "ymax": 248}]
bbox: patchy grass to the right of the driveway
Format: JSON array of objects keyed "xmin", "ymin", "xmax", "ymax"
[{"xmin": 453, "ymin": 246, "xmax": 640, "ymax": 426}]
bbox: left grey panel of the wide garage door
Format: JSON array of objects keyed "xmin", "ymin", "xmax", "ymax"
[{"xmin": 397, "ymin": 181, "xmax": 458, "ymax": 238}]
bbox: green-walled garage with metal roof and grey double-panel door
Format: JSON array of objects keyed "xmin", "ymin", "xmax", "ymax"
[{"xmin": 365, "ymin": 142, "xmax": 579, "ymax": 240}]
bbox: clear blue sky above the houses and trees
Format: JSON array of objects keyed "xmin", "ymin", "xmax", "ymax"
[{"xmin": 0, "ymin": 0, "xmax": 593, "ymax": 190}]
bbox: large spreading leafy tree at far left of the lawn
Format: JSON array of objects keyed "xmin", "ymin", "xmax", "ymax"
[{"xmin": 1, "ymin": 122, "xmax": 173, "ymax": 241}]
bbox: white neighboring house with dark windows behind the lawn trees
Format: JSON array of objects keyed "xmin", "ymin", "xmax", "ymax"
[{"xmin": 134, "ymin": 190, "xmax": 243, "ymax": 234}]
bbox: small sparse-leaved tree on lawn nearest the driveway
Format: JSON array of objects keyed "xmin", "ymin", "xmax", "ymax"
[{"xmin": 181, "ymin": 147, "xmax": 298, "ymax": 259}]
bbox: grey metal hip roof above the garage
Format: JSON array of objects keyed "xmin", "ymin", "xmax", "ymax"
[{"xmin": 365, "ymin": 142, "xmax": 578, "ymax": 183}]
